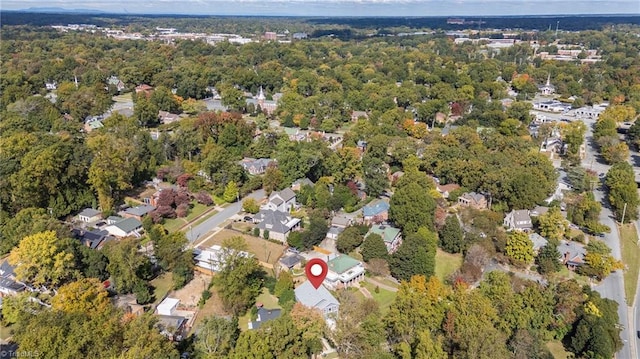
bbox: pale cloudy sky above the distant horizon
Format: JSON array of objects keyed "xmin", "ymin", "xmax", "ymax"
[{"xmin": 0, "ymin": 0, "xmax": 640, "ymax": 16}]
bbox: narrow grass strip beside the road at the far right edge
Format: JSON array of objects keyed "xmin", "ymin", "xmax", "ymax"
[{"xmin": 618, "ymin": 223, "xmax": 640, "ymax": 304}]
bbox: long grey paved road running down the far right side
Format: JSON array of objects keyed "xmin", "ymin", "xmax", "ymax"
[{"xmin": 582, "ymin": 119, "xmax": 640, "ymax": 359}]
